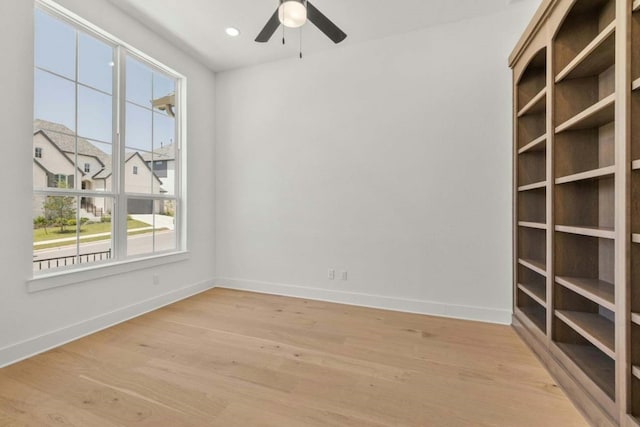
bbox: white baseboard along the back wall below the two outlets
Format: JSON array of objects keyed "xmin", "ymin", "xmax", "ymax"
[{"xmin": 215, "ymin": 277, "xmax": 512, "ymax": 325}]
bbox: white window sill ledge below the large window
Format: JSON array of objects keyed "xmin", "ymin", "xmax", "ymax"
[{"xmin": 27, "ymin": 251, "xmax": 190, "ymax": 293}]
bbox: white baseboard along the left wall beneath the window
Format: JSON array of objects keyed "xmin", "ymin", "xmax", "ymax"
[{"xmin": 0, "ymin": 280, "xmax": 214, "ymax": 368}]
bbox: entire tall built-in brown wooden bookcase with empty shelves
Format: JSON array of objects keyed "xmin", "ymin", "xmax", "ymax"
[{"xmin": 510, "ymin": 0, "xmax": 640, "ymax": 426}]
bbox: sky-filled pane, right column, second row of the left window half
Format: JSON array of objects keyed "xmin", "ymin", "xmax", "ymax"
[{"xmin": 78, "ymin": 86, "xmax": 113, "ymax": 142}]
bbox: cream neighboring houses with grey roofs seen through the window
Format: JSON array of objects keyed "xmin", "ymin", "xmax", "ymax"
[{"xmin": 33, "ymin": 120, "xmax": 166, "ymax": 218}]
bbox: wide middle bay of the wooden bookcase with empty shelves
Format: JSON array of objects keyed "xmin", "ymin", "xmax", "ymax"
[{"xmin": 551, "ymin": 0, "xmax": 618, "ymax": 417}]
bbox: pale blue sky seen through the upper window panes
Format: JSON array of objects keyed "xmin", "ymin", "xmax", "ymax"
[{"xmin": 34, "ymin": 9, "xmax": 175, "ymax": 156}]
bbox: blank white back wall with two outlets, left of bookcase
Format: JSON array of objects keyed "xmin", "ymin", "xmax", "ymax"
[{"xmin": 216, "ymin": 0, "xmax": 539, "ymax": 323}]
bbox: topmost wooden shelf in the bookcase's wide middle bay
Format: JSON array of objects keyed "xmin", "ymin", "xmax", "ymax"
[{"xmin": 556, "ymin": 21, "xmax": 616, "ymax": 83}]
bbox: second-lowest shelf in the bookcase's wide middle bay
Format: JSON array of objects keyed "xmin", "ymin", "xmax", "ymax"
[{"xmin": 555, "ymin": 310, "xmax": 616, "ymax": 360}]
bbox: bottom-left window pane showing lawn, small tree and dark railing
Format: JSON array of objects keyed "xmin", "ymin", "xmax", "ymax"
[{"xmin": 33, "ymin": 194, "xmax": 78, "ymax": 271}]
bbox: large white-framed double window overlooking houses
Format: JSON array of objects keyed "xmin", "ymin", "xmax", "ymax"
[{"xmin": 33, "ymin": 0, "xmax": 184, "ymax": 276}]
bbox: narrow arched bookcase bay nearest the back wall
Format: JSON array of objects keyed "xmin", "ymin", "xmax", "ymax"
[{"xmin": 514, "ymin": 45, "xmax": 549, "ymax": 336}]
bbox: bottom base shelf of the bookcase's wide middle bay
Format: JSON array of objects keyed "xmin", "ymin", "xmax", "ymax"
[{"xmin": 556, "ymin": 342, "xmax": 616, "ymax": 400}]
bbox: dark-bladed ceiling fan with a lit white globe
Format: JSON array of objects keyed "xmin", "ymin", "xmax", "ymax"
[{"xmin": 256, "ymin": 0, "xmax": 347, "ymax": 43}]
